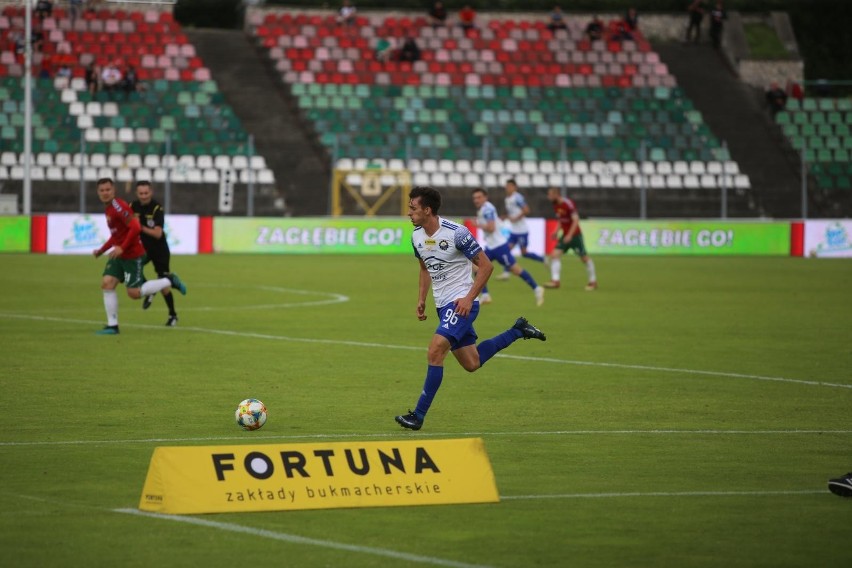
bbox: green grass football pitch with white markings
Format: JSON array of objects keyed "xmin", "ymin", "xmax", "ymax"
[{"xmin": 0, "ymin": 255, "xmax": 852, "ymax": 568}]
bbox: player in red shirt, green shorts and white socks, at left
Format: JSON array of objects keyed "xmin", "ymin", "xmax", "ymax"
[{"xmin": 92, "ymin": 178, "xmax": 186, "ymax": 335}]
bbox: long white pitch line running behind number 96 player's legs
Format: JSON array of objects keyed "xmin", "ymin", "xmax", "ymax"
[{"xmin": 6, "ymin": 313, "xmax": 852, "ymax": 390}]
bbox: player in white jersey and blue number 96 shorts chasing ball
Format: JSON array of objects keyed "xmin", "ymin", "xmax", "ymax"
[{"xmin": 396, "ymin": 187, "xmax": 547, "ymax": 430}]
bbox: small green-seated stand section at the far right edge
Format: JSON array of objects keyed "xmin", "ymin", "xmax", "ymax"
[{"xmin": 775, "ymin": 98, "xmax": 852, "ymax": 190}]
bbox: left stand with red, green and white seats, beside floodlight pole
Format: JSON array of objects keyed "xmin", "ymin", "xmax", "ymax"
[{"xmin": 0, "ymin": 5, "xmax": 274, "ymax": 184}]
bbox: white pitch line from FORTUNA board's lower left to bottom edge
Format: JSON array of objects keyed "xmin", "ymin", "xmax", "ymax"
[{"xmin": 113, "ymin": 509, "xmax": 486, "ymax": 568}]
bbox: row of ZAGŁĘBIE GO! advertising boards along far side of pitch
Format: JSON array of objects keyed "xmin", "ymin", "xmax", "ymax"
[{"xmin": 0, "ymin": 213, "xmax": 852, "ymax": 258}]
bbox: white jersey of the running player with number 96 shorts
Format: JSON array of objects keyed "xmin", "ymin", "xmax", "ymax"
[{"xmin": 411, "ymin": 217, "xmax": 482, "ymax": 308}]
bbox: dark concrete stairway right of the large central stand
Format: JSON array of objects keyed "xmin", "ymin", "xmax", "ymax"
[{"xmin": 654, "ymin": 43, "xmax": 801, "ymax": 217}]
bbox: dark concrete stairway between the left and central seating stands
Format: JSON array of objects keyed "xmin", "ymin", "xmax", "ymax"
[{"xmin": 184, "ymin": 28, "xmax": 331, "ymax": 216}]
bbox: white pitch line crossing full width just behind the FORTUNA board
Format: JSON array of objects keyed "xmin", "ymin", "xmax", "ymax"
[{"xmin": 0, "ymin": 430, "xmax": 852, "ymax": 447}]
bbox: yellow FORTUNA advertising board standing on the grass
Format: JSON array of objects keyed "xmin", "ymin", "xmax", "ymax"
[{"xmin": 139, "ymin": 438, "xmax": 500, "ymax": 514}]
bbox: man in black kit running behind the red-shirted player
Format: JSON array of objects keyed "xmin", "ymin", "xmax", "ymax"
[{"xmin": 130, "ymin": 181, "xmax": 177, "ymax": 327}]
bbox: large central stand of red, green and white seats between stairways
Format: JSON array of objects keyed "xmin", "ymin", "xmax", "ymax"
[{"xmin": 249, "ymin": 12, "xmax": 750, "ymax": 189}]
